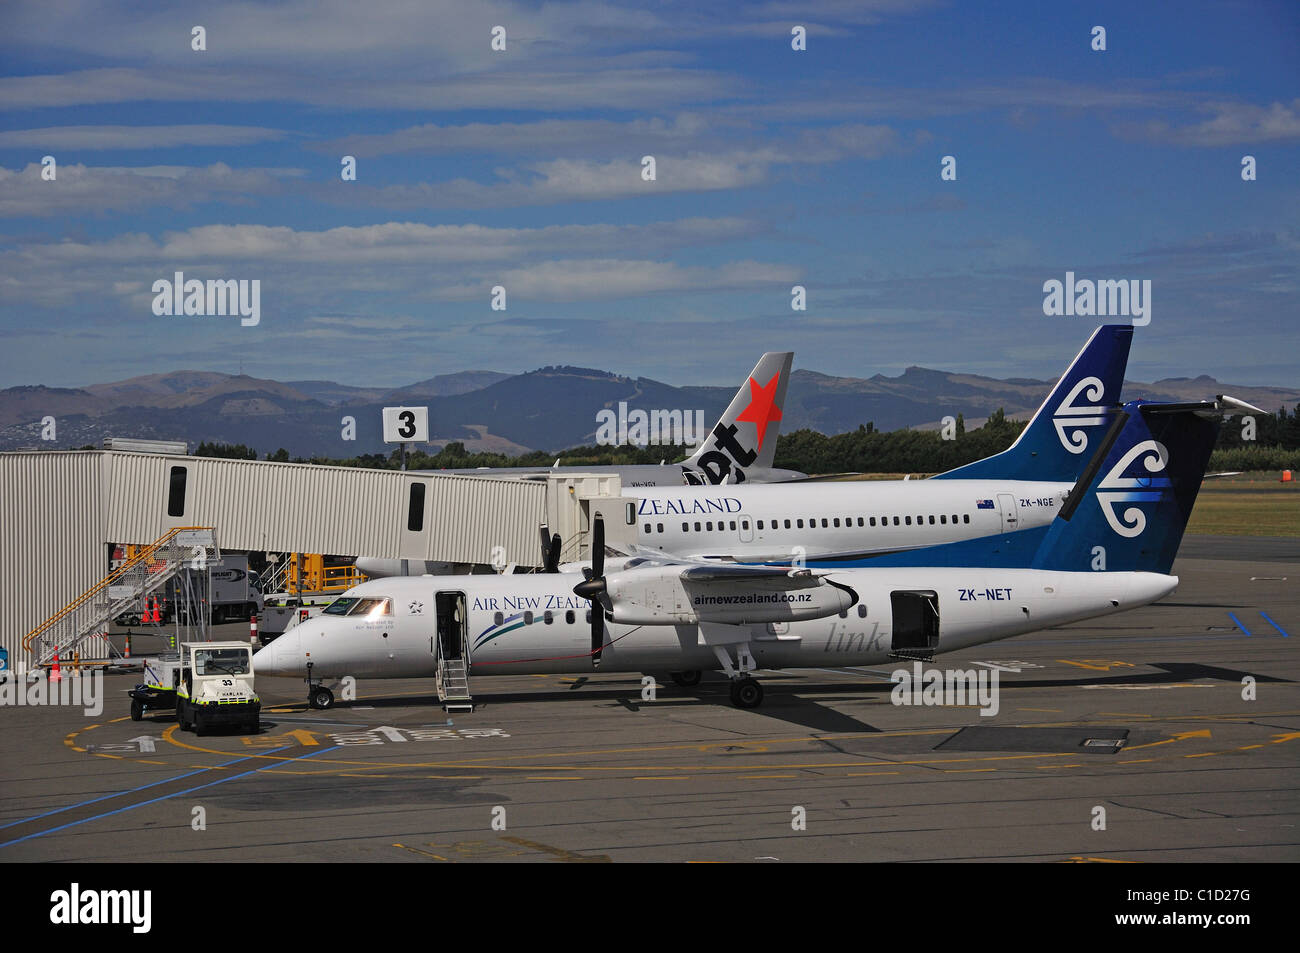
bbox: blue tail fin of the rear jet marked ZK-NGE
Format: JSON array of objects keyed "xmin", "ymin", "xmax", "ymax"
[{"xmin": 933, "ymin": 324, "xmax": 1134, "ymax": 482}]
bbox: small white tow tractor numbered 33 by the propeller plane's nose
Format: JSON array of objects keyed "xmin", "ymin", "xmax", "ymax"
[{"xmin": 129, "ymin": 642, "xmax": 261, "ymax": 735}]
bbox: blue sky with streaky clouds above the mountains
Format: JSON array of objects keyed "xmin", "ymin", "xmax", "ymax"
[{"xmin": 0, "ymin": 0, "xmax": 1300, "ymax": 387}]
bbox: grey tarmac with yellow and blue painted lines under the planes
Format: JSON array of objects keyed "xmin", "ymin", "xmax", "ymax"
[{"xmin": 0, "ymin": 537, "xmax": 1300, "ymax": 863}]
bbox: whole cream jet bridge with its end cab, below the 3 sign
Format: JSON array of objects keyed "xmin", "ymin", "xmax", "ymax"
[{"xmin": 0, "ymin": 450, "xmax": 634, "ymax": 670}]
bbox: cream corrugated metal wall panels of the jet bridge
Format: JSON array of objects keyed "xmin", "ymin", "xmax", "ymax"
[{"xmin": 0, "ymin": 451, "xmax": 546, "ymax": 663}]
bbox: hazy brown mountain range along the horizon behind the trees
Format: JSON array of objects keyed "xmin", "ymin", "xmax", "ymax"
[{"xmin": 0, "ymin": 367, "xmax": 1300, "ymax": 458}]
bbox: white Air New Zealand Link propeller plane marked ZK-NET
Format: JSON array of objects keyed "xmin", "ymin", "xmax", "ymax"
[{"xmin": 254, "ymin": 387, "xmax": 1222, "ymax": 707}]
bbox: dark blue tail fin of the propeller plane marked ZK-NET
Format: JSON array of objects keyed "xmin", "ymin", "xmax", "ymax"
[{"xmin": 1034, "ymin": 400, "xmax": 1221, "ymax": 573}]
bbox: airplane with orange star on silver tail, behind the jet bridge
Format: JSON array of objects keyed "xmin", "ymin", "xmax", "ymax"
[{"xmin": 356, "ymin": 351, "xmax": 807, "ymax": 579}]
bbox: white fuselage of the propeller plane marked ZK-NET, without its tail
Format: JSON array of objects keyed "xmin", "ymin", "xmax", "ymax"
[{"xmin": 256, "ymin": 568, "xmax": 1178, "ymax": 680}]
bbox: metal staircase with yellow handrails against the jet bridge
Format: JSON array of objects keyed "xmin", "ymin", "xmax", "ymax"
[{"xmin": 22, "ymin": 527, "xmax": 221, "ymax": 668}]
